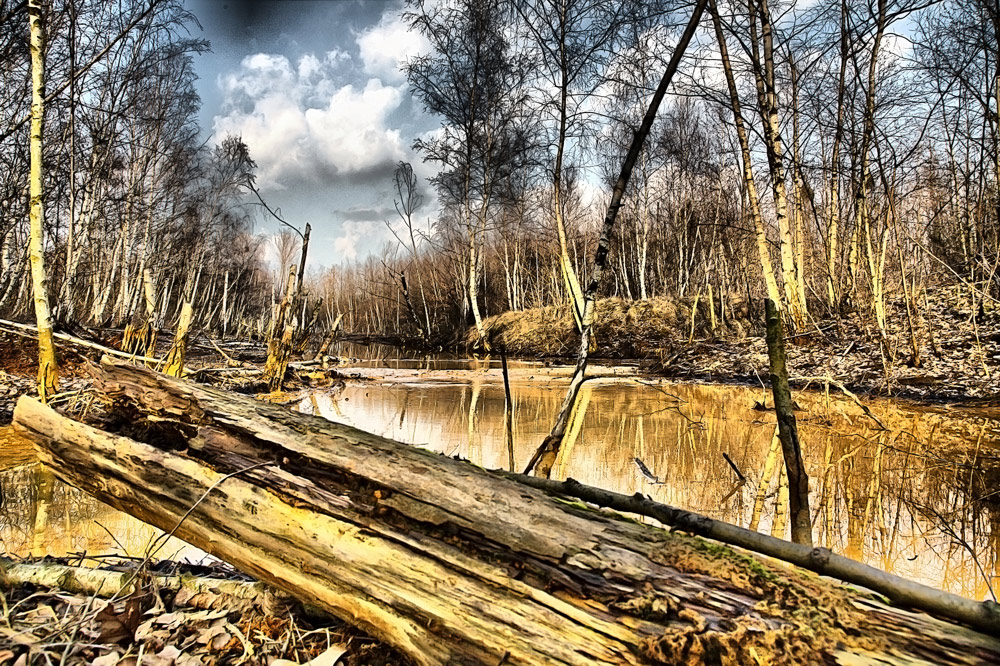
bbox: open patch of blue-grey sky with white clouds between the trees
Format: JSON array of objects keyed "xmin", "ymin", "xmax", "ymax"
[{"xmin": 186, "ymin": 0, "xmax": 437, "ymax": 266}]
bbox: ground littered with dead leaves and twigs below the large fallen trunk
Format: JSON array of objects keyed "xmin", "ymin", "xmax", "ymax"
[{"xmin": 0, "ymin": 558, "xmax": 408, "ymax": 666}]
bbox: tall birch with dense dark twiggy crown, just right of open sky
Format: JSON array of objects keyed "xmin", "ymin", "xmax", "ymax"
[{"xmin": 407, "ymin": 0, "xmax": 528, "ymax": 349}]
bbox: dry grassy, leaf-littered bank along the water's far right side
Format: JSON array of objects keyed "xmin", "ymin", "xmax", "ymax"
[{"xmin": 476, "ymin": 289, "xmax": 1000, "ymax": 404}]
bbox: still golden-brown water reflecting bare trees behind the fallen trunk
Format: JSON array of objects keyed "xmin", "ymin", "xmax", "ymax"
[{"xmin": 0, "ymin": 361, "xmax": 1000, "ymax": 599}]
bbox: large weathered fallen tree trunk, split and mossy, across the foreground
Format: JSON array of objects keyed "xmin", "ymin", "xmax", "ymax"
[{"xmin": 15, "ymin": 361, "xmax": 1000, "ymax": 665}]
